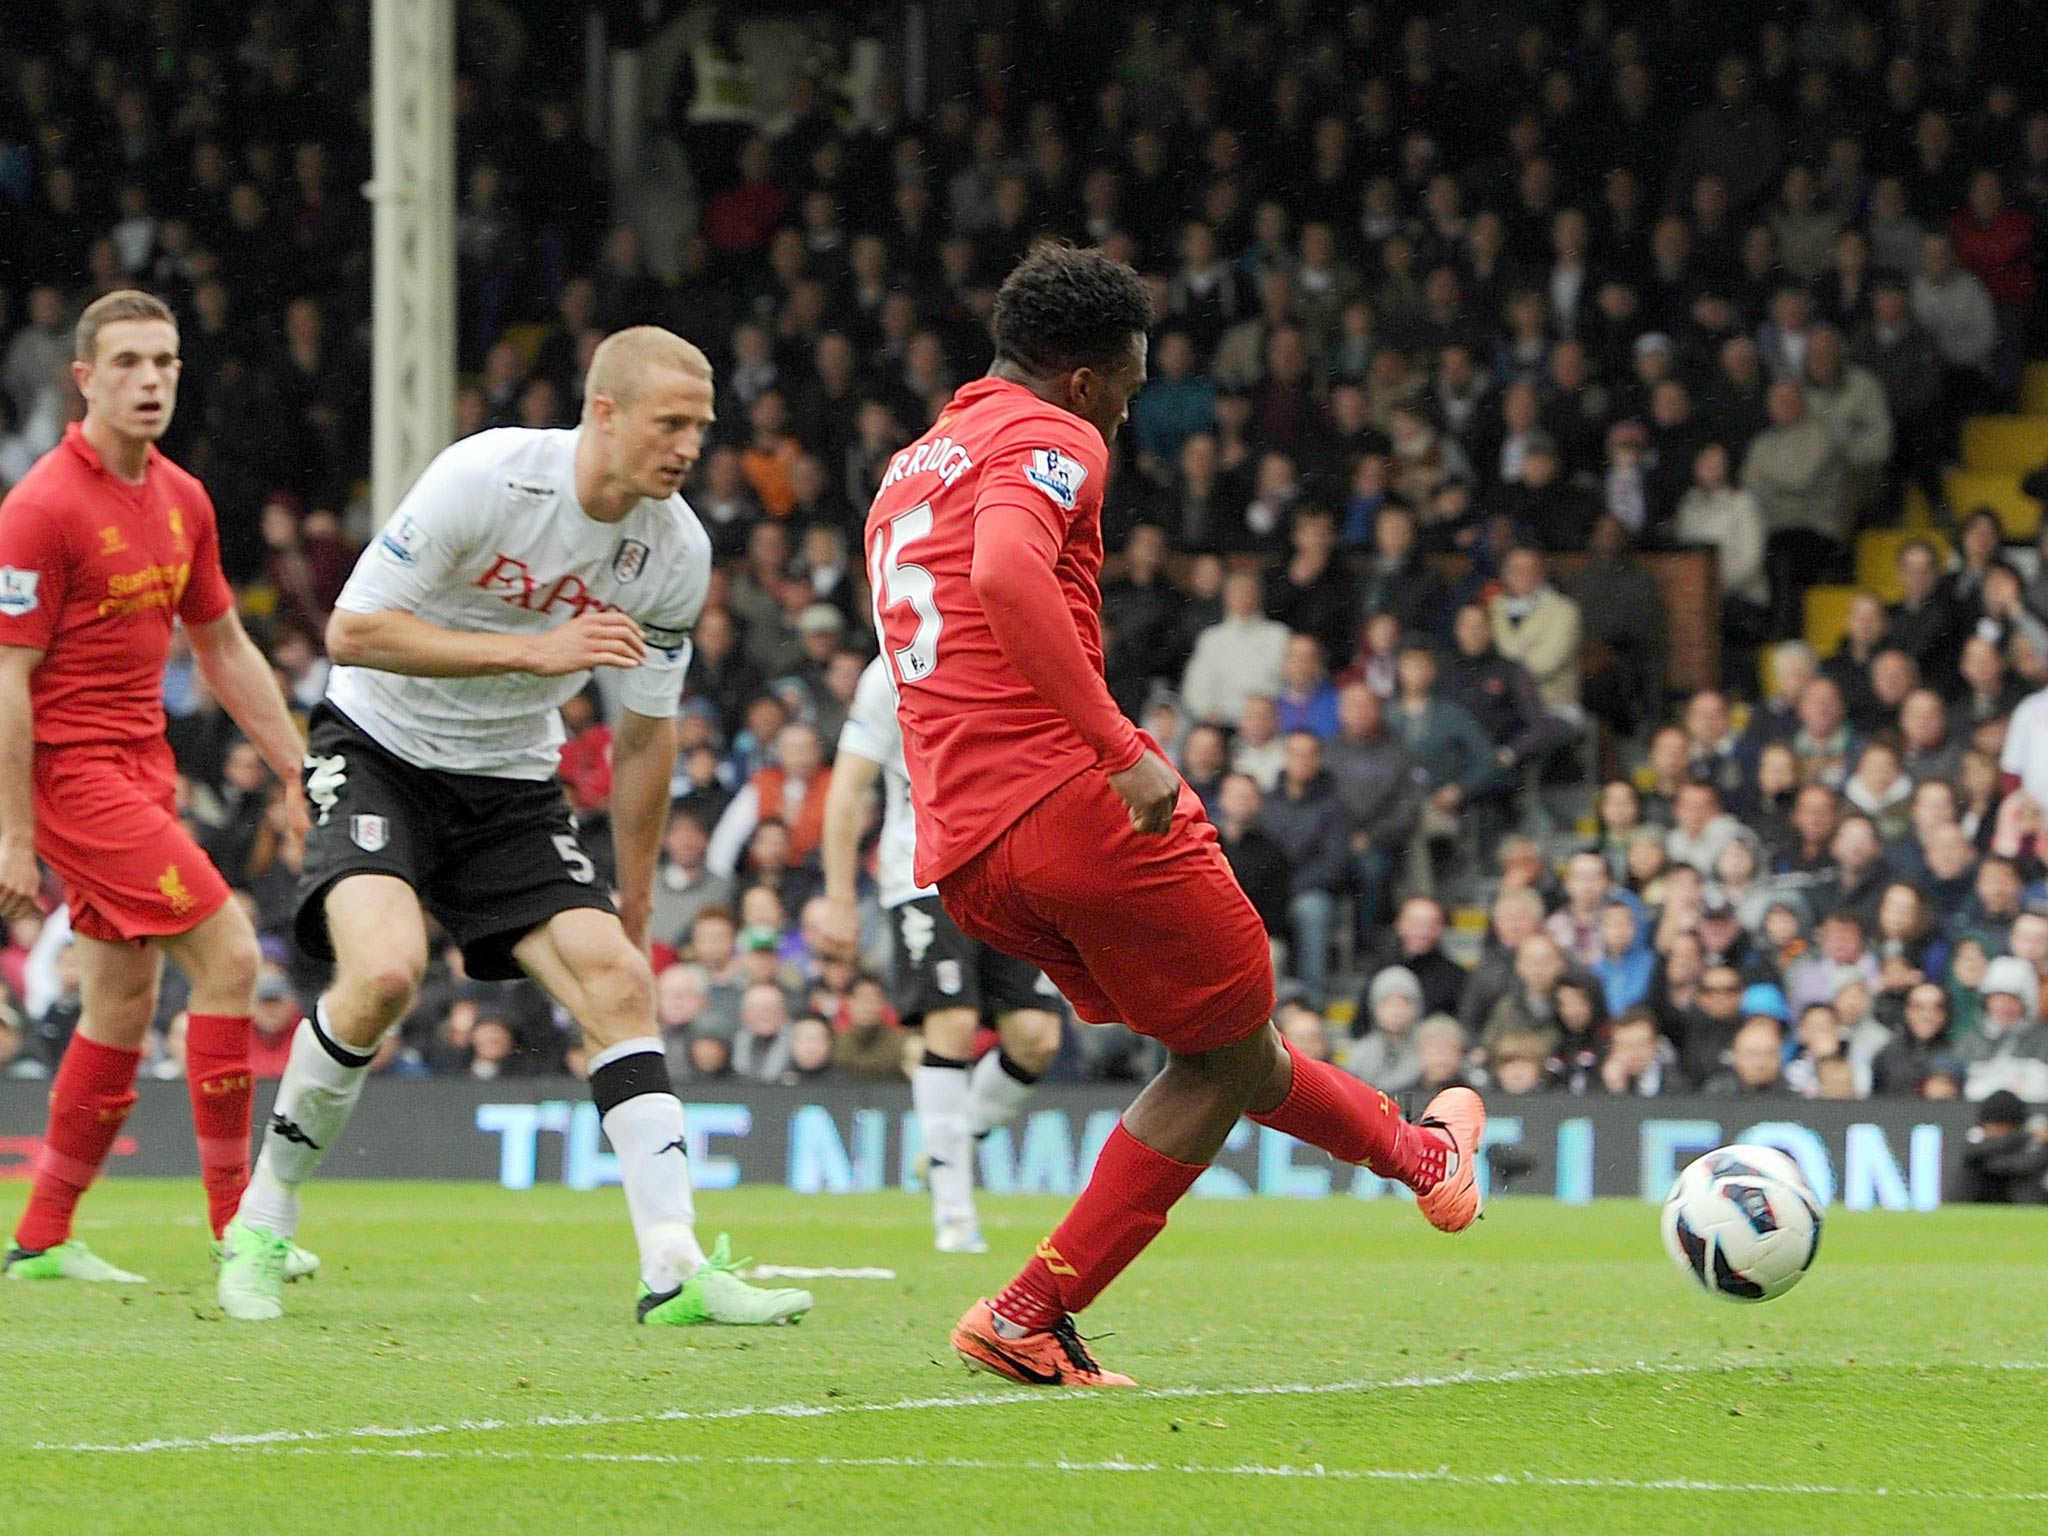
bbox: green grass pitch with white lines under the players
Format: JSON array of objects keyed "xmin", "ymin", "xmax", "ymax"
[{"xmin": 0, "ymin": 1180, "xmax": 2048, "ymax": 1536}]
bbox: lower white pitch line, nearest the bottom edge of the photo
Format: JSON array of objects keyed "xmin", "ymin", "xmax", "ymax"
[{"xmin": 203, "ymin": 1446, "xmax": 2048, "ymax": 1503}]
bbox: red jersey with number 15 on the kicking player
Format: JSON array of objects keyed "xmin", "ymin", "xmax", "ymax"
[{"xmin": 866, "ymin": 379, "xmax": 1139, "ymax": 885}]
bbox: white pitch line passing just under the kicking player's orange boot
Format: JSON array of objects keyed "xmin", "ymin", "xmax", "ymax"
[{"xmin": 31, "ymin": 1360, "xmax": 2048, "ymax": 1456}]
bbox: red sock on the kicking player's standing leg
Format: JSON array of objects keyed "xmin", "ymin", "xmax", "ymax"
[{"xmin": 993, "ymin": 1122, "xmax": 1202, "ymax": 1331}]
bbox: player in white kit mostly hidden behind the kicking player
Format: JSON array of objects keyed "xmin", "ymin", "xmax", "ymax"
[{"xmin": 823, "ymin": 657, "xmax": 1059, "ymax": 1253}]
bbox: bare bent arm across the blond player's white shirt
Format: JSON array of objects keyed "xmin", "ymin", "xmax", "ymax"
[{"xmin": 328, "ymin": 608, "xmax": 647, "ymax": 678}]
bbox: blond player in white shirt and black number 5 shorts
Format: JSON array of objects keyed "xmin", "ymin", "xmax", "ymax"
[{"xmin": 219, "ymin": 326, "xmax": 811, "ymax": 1323}]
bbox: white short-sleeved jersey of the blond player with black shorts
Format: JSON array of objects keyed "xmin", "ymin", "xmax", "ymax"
[{"xmin": 328, "ymin": 426, "xmax": 711, "ymax": 778}]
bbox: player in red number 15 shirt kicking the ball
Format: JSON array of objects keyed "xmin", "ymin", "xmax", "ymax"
[{"xmin": 866, "ymin": 244, "xmax": 1485, "ymax": 1386}]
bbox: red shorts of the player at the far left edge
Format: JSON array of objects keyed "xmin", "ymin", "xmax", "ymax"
[{"xmin": 35, "ymin": 741, "xmax": 227, "ymax": 944}]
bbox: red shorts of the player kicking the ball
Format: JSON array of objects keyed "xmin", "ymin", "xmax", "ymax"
[{"xmin": 938, "ymin": 770, "xmax": 1274, "ymax": 1055}]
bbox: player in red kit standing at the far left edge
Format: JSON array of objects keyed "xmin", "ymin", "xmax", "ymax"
[{"xmin": 0, "ymin": 291, "xmax": 309, "ymax": 1282}]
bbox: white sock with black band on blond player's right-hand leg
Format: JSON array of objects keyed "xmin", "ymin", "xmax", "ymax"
[{"xmin": 590, "ymin": 1034, "xmax": 705, "ymax": 1294}]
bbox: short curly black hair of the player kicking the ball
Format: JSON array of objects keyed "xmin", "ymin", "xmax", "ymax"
[{"xmin": 995, "ymin": 242, "xmax": 1151, "ymax": 375}]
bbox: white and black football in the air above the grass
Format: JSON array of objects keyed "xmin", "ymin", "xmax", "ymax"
[{"xmin": 1663, "ymin": 1147, "xmax": 1821, "ymax": 1300}]
